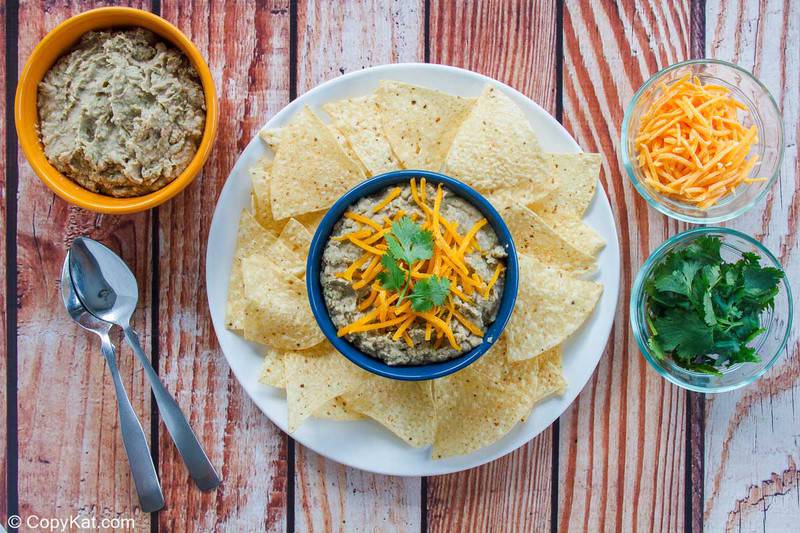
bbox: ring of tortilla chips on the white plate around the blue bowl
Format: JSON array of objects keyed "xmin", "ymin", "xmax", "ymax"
[{"xmin": 226, "ymin": 81, "xmax": 604, "ymax": 458}]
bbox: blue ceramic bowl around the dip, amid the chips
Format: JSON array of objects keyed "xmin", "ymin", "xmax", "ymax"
[{"xmin": 306, "ymin": 170, "xmax": 519, "ymax": 381}]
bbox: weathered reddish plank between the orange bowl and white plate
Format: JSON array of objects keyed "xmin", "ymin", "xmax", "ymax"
[{"xmin": 159, "ymin": 0, "xmax": 289, "ymax": 531}]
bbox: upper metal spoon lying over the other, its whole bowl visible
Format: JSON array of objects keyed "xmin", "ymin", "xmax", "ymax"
[{"xmin": 69, "ymin": 237, "xmax": 220, "ymax": 490}]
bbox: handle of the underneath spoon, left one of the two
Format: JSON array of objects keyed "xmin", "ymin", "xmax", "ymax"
[{"xmin": 100, "ymin": 334, "xmax": 164, "ymax": 513}]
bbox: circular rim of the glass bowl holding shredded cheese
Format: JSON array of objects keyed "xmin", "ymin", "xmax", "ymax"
[{"xmin": 619, "ymin": 59, "xmax": 786, "ymax": 224}]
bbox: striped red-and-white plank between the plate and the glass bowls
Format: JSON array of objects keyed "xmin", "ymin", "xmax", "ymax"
[{"xmin": 558, "ymin": 1, "xmax": 691, "ymax": 531}]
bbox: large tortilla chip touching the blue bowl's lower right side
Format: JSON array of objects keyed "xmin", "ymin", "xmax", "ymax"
[{"xmin": 506, "ymin": 254, "xmax": 603, "ymax": 361}]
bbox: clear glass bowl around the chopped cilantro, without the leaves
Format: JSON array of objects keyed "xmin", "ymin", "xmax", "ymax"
[{"xmin": 630, "ymin": 227, "xmax": 793, "ymax": 392}]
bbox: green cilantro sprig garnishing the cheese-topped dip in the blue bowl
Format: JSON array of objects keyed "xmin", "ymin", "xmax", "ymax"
[{"xmin": 378, "ymin": 216, "xmax": 450, "ymax": 312}]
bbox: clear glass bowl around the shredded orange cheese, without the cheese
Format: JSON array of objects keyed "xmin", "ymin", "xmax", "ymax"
[{"xmin": 620, "ymin": 59, "xmax": 783, "ymax": 224}]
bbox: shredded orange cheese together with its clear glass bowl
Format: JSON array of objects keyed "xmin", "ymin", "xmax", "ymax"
[{"xmin": 621, "ymin": 60, "xmax": 783, "ymax": 224}]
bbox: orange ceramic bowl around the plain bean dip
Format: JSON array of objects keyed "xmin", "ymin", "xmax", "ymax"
[{"xmin": 14, "ymin": 7, "xmax": 219, "ymax": 215}]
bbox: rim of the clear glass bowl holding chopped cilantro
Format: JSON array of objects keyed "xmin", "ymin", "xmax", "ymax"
[{"xmin": 628, "ymin": 226, "xmax": 794, "ymax": 393}]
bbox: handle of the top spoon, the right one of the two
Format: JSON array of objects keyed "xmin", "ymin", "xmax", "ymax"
[{"xmin": 123, "ymin": 326, "xmax": 221, "ymax": 490}]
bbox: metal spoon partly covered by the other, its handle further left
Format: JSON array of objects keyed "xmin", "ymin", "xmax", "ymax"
[{"xmin": 61, "ymin": 257, "xmax": 164, "ymax": 513}]
